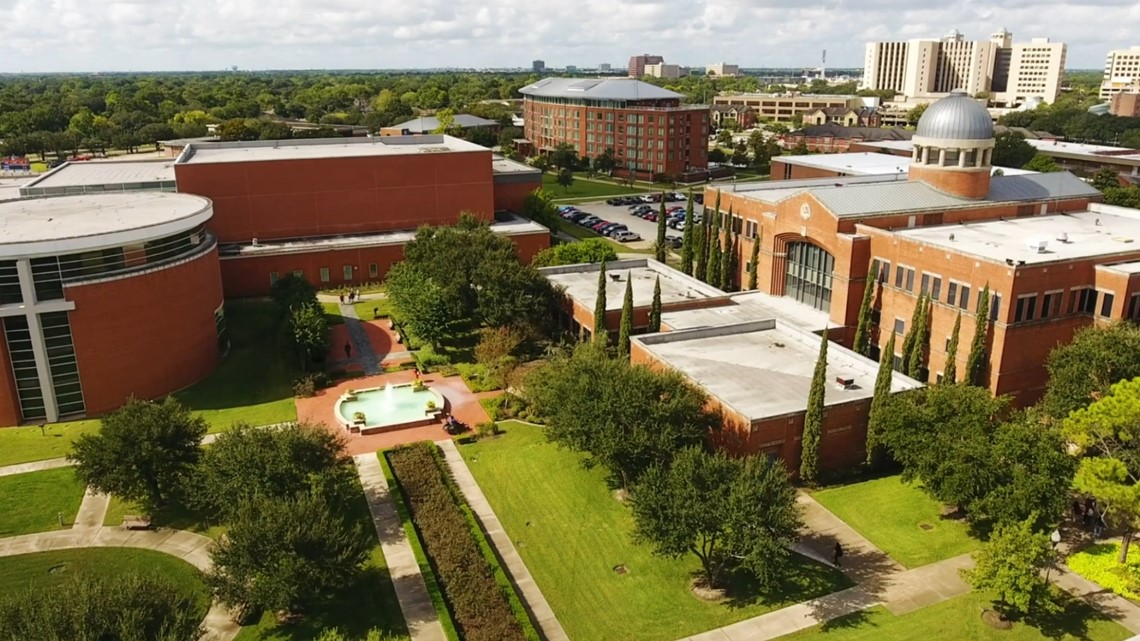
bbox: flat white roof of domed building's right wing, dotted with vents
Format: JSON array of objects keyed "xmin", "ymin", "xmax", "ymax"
[{"xmin": 894, "ymin": 203, "xmax": 1140, "ymax": 265}]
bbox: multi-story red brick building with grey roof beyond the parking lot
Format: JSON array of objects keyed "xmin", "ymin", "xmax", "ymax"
[{"xmin": 519, "ymin": 78, "xmax": 709, "ymax": 178}]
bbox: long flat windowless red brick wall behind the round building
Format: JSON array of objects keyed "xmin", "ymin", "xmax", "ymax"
[{"xmin": 174, "ymin": 151, "xmax": 495, "ymax": 243}]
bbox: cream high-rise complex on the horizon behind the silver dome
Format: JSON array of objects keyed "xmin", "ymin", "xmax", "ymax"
[{"xmin": 863, "ymin": 29, "xmax": 1066, "ymax": 105}]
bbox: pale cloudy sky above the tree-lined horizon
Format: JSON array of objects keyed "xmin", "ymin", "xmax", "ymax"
[{"xmin": 0, "ymin": 0, "xmax": 1140, "ymax": 72}]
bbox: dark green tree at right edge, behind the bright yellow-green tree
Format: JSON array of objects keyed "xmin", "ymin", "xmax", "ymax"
[{"xmin": 1039, "ymin": 323, "xmax": 1140, "ymax": 421}]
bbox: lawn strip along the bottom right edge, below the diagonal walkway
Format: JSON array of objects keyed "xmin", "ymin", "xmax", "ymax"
[{"xmin": 779, "ymin": 594, "xmax": 1131, "ymax": 641}]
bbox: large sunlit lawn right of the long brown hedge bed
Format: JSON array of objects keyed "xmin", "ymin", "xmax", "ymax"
[{"xmin": 461, "ymin": 422, "xmax": 849, "ymax": 641}]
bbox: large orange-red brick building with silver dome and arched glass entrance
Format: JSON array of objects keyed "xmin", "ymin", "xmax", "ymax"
[{"xmin": 705, "ymin": 88, "xmax": 1140, "ymax": 405}]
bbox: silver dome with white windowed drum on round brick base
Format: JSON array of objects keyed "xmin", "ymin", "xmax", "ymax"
[{"xmin": 910, "ymin": 89, "xmax": 994, "ymax": 200}]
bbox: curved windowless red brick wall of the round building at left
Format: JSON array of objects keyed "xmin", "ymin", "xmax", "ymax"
[{"xmin": 64, "ymin": 244, "xmax": 222, "ymax": 415}]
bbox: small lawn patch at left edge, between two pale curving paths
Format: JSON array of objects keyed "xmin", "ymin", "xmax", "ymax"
[{"xmin": 0, "ymin": 468, "xmax": 84, "ymax": 538}]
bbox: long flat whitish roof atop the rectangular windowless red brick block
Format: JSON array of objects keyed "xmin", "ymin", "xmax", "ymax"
[{"xmin": 177, "ymin": 135, "xmax": 490, "ymax": 164}]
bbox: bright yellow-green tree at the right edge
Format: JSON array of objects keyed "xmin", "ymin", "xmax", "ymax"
[{"xmin": 1062, "ymin": 378, "xmax": 1140, "ymax": 563}]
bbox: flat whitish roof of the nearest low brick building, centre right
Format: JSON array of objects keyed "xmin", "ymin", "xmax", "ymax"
[{"xmin": 633, "ymin": 321, "xmax": 921, "ymax": 421}]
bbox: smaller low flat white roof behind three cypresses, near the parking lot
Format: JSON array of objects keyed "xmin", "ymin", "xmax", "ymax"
[{"xmin": 539, "ymin": 258, "xmax": 725, "ymax": 310}]
